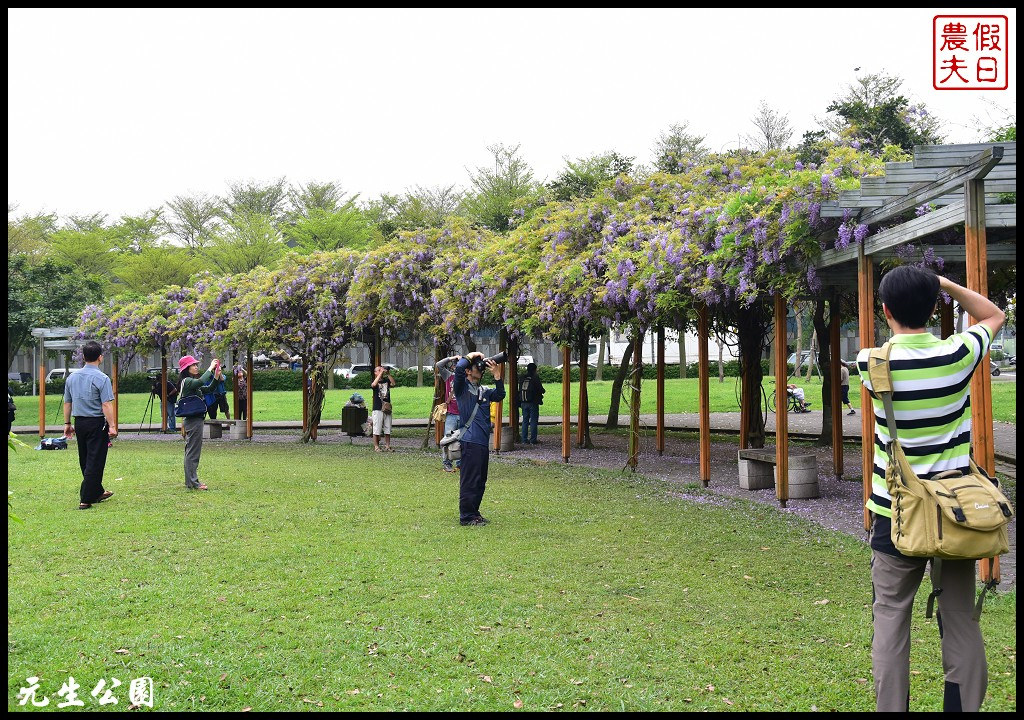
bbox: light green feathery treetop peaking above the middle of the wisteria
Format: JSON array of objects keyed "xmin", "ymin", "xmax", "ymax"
[{"xmin": 462, "ymin": 144, "xmax": 541, "ymax": 232}]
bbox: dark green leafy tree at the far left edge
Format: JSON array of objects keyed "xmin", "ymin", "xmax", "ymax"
[{"xmin": 7, "ymin": 254, "xmax": 102, "ymax": 369}]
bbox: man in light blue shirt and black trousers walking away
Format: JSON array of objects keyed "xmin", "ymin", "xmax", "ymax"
[{"xmin": 65, "ymin": 341, "xmax": 118, "ymax": 510}]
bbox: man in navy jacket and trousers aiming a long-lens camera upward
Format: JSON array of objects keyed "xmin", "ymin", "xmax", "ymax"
[{"xmin": 452, "ymin": 352, "xmax": 505, "ymax": 525}]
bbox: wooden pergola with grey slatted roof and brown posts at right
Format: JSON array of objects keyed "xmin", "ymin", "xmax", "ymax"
[{"xmin": 544, "ymin": 142, "xmax": 1017, "ymax": 530}]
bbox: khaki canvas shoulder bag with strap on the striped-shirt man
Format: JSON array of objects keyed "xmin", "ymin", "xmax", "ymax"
[{"xmin": 867, "ymin": 342, "xmax": 1014, "ymax": 618}]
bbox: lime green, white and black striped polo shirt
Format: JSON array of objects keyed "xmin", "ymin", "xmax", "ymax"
[{"xmin": 857, "ymin": 325, "xmax": 991, "ymax": 517}]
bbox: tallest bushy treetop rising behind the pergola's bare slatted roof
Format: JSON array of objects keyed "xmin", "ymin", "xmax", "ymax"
[{"xmin": 822, "ymin": 72, "xmax": 942, "ymax": 156}]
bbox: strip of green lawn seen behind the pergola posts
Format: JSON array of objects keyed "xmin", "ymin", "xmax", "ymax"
[{"xmin": 24, "ymin": 376, "xmax": 1017, "ymax": 425}]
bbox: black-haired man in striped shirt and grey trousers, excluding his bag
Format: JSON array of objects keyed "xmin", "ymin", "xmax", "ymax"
[{"xmin": 857, "ymin": 265, "xmax": 1006, "ymax": 712}]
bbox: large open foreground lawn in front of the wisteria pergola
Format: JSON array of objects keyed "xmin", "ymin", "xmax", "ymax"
[{"xmin": 7, "ymin": 442, "xmax": 1016, "ymax": 712}]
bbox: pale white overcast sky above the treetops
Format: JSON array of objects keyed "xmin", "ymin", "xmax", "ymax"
[{"xmin": 7, "ymin": 8, "xmax": 1018, "ymax": 220}]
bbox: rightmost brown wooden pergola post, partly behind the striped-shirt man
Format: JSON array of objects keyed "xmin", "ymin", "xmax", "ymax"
[{"xmin": 950, "ymin": 180, "xmax": 999, "ymax": 582}]
